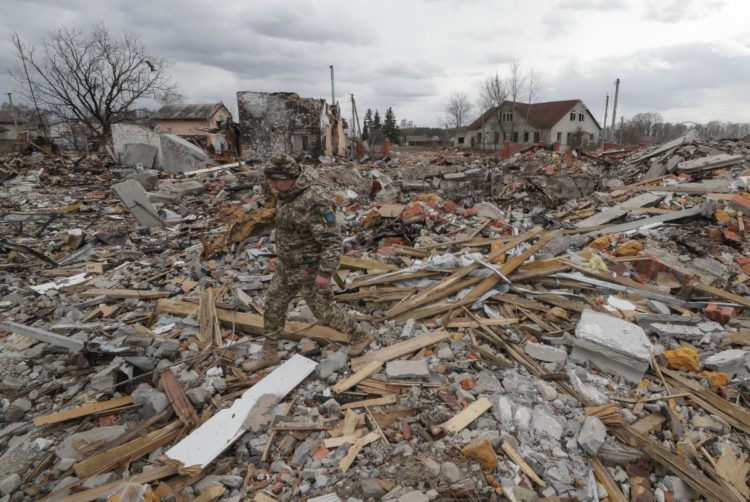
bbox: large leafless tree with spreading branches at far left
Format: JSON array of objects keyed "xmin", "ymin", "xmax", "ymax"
[{"xmin": 11, "ymin": 24, "xmax": 173, "ymax": 137}]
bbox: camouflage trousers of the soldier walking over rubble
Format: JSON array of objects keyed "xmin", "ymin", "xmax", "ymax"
[{"xmin": 263, "ymin": 263, "xmax": 367, "ymax": 341}]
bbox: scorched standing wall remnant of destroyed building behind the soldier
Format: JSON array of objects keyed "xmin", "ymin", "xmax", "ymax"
[{"xmin": 237, "ymin": 91, "xmax": 346, "ymax": 159}]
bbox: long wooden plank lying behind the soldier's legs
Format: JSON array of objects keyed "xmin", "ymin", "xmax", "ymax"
[{"xmin": 157, "ymin": 299, "xmax": 349, "ymax": 343}]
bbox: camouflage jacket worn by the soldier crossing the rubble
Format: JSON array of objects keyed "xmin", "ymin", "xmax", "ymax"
[{"xmin": 275, "ymin": 168, "xmax": 343, "ymax": 277}]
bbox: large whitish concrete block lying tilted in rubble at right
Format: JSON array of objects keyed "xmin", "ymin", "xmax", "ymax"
[{"xmin": 570, "ymin": 309, "xmax": 653, "ymax": 383}]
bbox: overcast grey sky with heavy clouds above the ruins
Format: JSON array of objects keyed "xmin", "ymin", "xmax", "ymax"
[{"xmin": 0, "ymin": 0, "xmax": 750, "ymax": 126}]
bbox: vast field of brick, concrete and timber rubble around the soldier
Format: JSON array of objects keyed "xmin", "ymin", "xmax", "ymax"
[{"xmin": 0, "ymin": 136, "xmax": 750, "ymax": 502}]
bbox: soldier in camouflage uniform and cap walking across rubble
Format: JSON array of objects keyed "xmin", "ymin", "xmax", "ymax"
[{"xmin": 242, "ymin": 155, "xmax": 374, "ymax": 371}]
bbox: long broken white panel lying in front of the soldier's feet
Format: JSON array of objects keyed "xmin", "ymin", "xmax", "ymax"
[{"xmin": 164, "ymin": 354, "xmax": 318, "ymax": 470}]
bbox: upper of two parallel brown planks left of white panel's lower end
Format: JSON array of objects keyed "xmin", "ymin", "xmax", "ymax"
[{"xmin": 73, "ymin": 420, "xmax": 183, "ymax": 478}]
